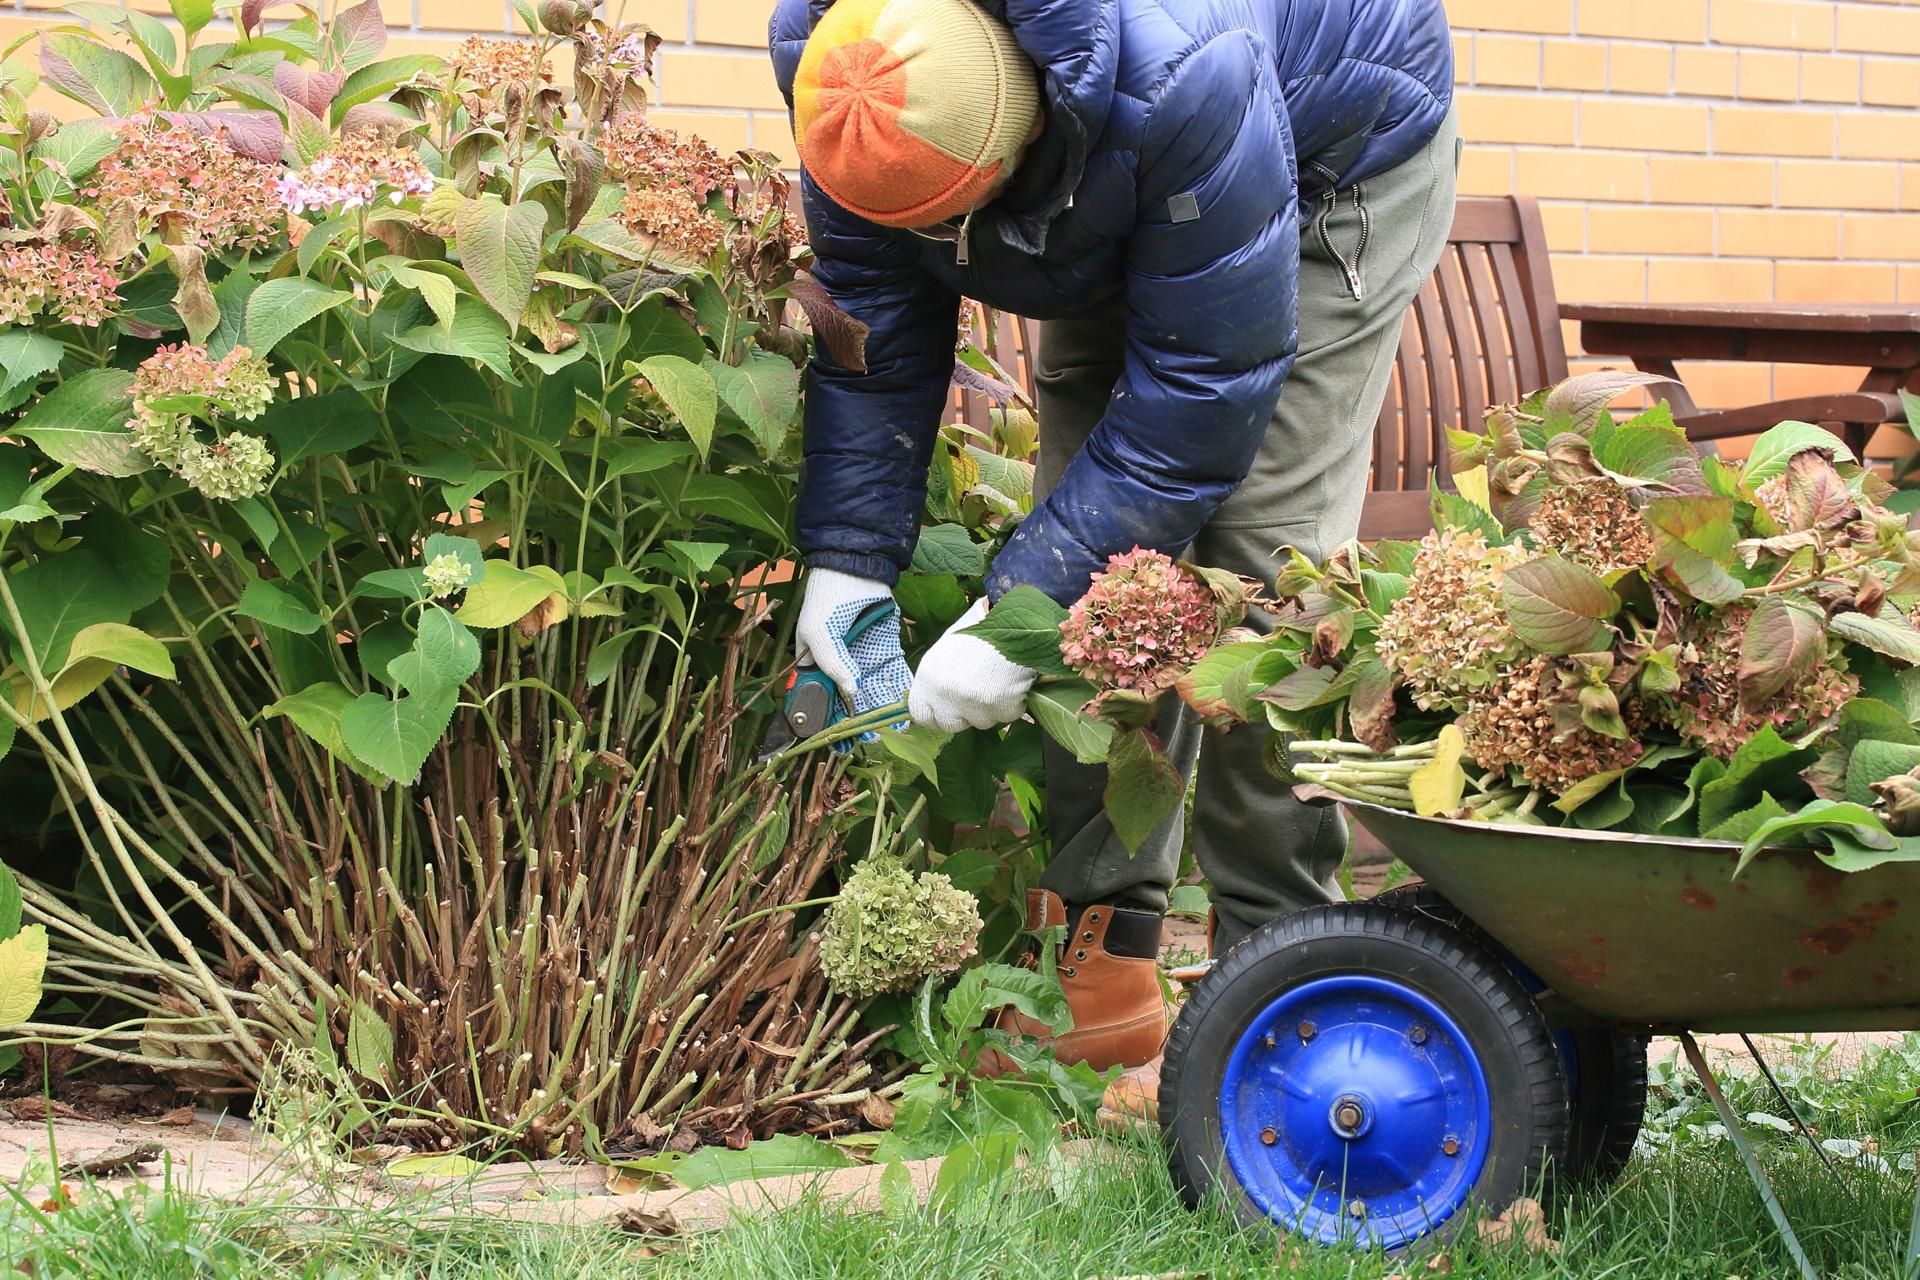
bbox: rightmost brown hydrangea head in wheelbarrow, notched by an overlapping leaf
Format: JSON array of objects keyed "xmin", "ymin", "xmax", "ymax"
[{"xmin": 1655, "ymin": 604, "xmax": 1860, "ymax": 760}]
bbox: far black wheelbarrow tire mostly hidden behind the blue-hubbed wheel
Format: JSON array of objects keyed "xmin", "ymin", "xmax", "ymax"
[{"xmin": 1373, "ymin": 883, "xmax": 1647, "ymax": 1186}]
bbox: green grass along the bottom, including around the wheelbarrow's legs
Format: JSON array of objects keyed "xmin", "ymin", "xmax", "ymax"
[{"xmin": 0, "ymin": 1034, "xmax": 1920, "ymax": 1280}]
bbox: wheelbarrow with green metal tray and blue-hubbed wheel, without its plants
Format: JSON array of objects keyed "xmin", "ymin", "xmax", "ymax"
[{"xmin": 1160, "ymin": 802, "xmax": 1920, "ymax": 1280}]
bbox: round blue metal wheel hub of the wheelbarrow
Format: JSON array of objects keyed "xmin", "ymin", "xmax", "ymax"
[{"xmin": 1219, "ymin": 975, "xmax": 1492, "ymax": 1249}]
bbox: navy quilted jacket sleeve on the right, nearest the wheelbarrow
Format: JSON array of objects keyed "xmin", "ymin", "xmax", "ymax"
[{"xmin": 989, "ymin": 31, "xmax": 1300, "ymax": 603}]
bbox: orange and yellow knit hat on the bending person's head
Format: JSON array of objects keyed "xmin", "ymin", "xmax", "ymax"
[{"xmin": 793, "ymin": 0, "xmax": 1041, "ymax": 226}]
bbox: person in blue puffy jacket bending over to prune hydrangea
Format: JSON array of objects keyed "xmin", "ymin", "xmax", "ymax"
[{"xmin": 770, "ymin": 0, "xmax": 1459, "ymax": 1069}]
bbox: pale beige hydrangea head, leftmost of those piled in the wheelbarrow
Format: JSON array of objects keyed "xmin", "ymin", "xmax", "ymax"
[{"xmin": 1375, "ymin": 530, "xmax": 1526, "ymax": 710}]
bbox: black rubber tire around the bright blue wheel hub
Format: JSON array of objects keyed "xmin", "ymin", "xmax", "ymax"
[{"xmin": 1160, "ymin": 902, "xmax": 1567, "ymax": 1240}]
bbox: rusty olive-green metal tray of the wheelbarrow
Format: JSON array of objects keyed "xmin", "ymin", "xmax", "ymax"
[{"xmin": 1348, "ymin": 804, "xmax": 1920, "ymax": 1034}]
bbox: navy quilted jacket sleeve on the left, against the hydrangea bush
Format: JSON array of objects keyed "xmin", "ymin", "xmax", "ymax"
[{"xmin": 770, "ymin": 0, "xmax": 960, "ymax": 583}]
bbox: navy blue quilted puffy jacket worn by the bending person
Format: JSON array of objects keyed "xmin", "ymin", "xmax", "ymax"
[{"xmin": 770, "ymin": 0, "xmax": 1453, "ymax": 603}]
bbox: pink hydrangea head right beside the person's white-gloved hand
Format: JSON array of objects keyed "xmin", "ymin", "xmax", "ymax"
[{"xmin": 1060, "ymin": 547, "xmax": 1219, "ymax": 695}]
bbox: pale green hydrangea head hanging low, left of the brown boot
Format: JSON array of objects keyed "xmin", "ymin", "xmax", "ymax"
[{"xmin": 820, "ymin": 858, "xmax": 981, "ymax": 1000}]
